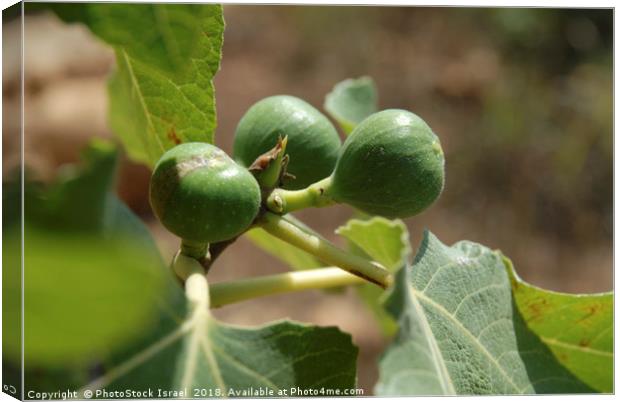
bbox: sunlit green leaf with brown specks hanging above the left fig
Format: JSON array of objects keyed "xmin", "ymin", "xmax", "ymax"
[{"xmin": 52, "ymin": 3, "xmax": 224, "ymax": 166}]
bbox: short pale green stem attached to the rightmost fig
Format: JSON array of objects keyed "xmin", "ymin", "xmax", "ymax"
[{"xmin": 265, "ymin": 176, "xmax": 336, "ymax": 215}]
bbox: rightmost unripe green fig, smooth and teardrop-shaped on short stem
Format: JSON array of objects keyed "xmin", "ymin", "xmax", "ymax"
[{"xmin": 329, "ymin": 109, "xmax": 444, "ymax": 218}]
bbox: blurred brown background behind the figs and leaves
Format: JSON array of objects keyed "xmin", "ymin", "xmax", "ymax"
[{"xmin": 3, "ymin": 5, "xmax": 613, "ymax": 393}]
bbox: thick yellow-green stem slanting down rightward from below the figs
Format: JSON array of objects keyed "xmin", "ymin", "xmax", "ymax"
[{"xmin": 257, "ymin": 212, "xmax": 393, "ymax": 289}]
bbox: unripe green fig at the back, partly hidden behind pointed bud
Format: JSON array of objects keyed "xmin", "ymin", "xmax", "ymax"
[{"xmin": 233, "ymin": 95, "xmax": 340, "ymax": 189}]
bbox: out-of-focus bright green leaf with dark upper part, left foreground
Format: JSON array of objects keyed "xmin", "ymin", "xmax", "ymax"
[{"xmin": 4, "ymin": 142, "xmax": 170, "ymax": 370}]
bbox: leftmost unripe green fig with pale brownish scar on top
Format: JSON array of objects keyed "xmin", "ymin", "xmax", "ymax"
[{"xmin": 150, "ymin": 142, "xmax": 261, "ymax": 243}]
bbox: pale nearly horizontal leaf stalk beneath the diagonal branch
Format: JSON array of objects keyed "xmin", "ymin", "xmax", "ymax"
[{"xmin": 209, "ymin": 267, "xmax": 366, "ymax": 308}]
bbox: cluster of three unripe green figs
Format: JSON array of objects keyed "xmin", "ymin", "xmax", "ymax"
[{"xmin": 150, "ymin": 95, "xmax": 444, "ymax": 243}]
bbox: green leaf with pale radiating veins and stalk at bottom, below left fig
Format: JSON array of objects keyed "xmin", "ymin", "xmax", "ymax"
[{"xmin": 85, "ymin": 257, "xmax": 357, "ymax": 398}]
